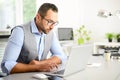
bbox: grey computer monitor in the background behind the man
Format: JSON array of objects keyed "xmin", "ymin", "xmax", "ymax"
[{"xmin": 58, "ymin": 28, "xmax": 74, "ymax": 42}]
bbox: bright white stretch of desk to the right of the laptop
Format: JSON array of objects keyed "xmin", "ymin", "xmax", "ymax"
[{"xmin": 67, "ymin": 57, "xmax": 120, "ymax": 80}]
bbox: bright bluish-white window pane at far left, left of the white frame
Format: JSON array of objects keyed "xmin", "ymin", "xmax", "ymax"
[{"xmin": 0, "ymin": 0, "xmax": 15, "ymax": 28}]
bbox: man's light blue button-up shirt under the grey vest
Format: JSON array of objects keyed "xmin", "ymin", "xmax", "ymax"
[{"xmin": 1, "ymin": 20, "xmax": 67, "ymax": 74}]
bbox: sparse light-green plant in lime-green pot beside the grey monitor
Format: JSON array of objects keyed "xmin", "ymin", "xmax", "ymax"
[{"xmin": 76, "ymin": 25, "xmax": 91, "ymax": 45}]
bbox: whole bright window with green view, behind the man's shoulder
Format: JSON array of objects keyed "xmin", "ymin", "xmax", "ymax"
[{"xmin": 0, "ymin": 0, "xmax": 36, "ymax": 29}]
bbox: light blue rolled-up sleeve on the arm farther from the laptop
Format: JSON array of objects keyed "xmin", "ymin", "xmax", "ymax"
[{"xmin": 1, "ymin": 27, "xmax": 24, "ymax": 74}]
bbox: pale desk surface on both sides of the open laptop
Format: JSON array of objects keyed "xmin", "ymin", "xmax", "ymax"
[{"xmin": 0, "ymin": 56, "xmax": 120, "ymax": 80}]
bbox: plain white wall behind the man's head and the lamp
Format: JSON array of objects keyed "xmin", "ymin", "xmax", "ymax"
[{"xmin": 37, "ymin": 0, "xmax": 120, "ymax": 41}]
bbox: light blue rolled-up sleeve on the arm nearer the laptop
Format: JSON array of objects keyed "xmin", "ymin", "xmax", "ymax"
[{"xmin": 50, "ymin": 33, "xmax": 67, "ymax": 64}]
